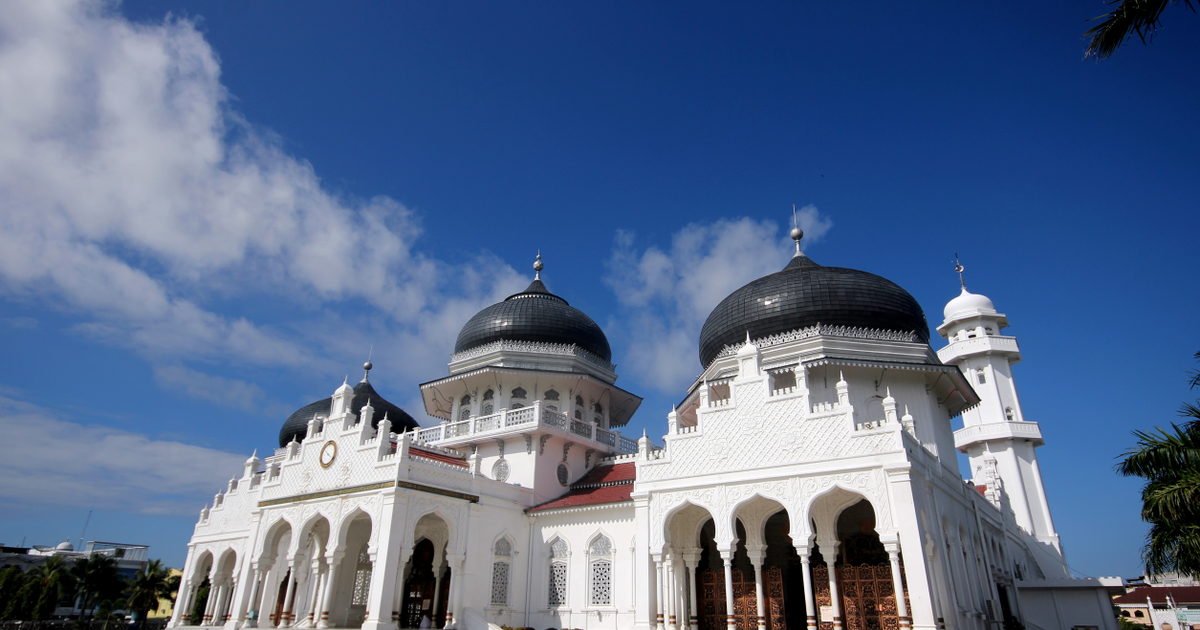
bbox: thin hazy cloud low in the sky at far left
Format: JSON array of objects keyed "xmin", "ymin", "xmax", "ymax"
[{"xmin": 0, "ymin": 397, "xmax": 246, "ymax": 515}]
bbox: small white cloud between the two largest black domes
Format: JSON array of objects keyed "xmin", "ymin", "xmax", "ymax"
[{"xmin": 605, "ymin": 212, "xmax": 833, "ymax": 395}]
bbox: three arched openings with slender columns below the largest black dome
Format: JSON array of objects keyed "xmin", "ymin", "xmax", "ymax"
[{"xmin": 658, "ymin": 499, "xmax": 911, "ymax": 630}]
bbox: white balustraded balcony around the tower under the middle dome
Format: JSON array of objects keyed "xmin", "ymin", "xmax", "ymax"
[{"xmin": 412, "ymin": 401, "xmax": 637, "ymax": 454}]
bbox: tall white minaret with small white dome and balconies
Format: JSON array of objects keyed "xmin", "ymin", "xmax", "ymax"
[{"xmin": 937, "ymin": 266, "xmax": 1062, "ymax": 554}]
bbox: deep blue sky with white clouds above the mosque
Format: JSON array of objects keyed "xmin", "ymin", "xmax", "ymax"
[{"xmin": 0, "ymin": 0, "xmax": 1200, "ymax": 576}]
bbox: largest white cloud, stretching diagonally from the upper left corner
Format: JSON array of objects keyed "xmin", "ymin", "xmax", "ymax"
[{"xmin": 0, "ymin": 0, "xmax": 530, "ymax": 398}]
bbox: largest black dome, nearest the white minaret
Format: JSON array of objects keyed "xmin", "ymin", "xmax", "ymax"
[{"xmin": 700, "ymin": 254, "xmax": 929, "ymax": 366}]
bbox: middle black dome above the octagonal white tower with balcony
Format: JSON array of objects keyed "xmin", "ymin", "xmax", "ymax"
[{"xmin": 454, "ymin": 280, "xmax": 612, "ymax": 362}]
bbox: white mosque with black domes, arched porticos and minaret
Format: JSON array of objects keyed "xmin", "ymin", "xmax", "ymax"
[{"xmin": 170, "ymin": 229, "xmax": 1117, "ymax": 630}]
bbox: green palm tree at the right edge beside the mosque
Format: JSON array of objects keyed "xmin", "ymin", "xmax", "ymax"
[{"xmin": 1117, "ymin": 353, "xmax": 1200, "ymax": 577}]
